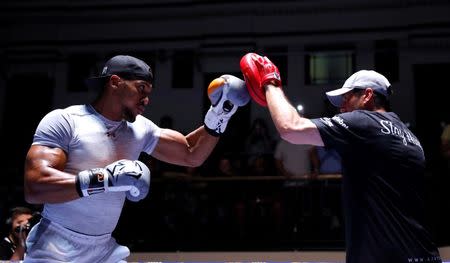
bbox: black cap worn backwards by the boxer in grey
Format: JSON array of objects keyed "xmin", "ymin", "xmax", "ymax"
[{"xmin": 85, "ymin": 55, "xmax": 153, "ymax": 89}]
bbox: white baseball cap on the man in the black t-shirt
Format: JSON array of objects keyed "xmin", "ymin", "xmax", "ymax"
[{"xmin": 326, "ymin": 70, "xmax": 392, "ymax": 107}]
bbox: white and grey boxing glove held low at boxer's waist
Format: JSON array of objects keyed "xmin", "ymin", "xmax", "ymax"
[{"xmin": 76, "ymin": 159, "xmax": 150, "ymax": 202}]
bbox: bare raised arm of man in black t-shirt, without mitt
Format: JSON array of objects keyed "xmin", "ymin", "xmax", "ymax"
[{"xmin": 265, "ymin": 84, "xmax": 323, "ymax": 146}]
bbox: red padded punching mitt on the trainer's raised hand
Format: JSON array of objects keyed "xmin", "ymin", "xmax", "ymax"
[{"xmin": 240, "ymin": 53, "xmax": 281, "ymax": 107}]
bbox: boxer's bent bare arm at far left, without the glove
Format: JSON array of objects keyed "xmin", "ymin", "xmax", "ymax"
[{"xmin": 24, "ymin": 145, "xmax": 79, "ymax": 204}]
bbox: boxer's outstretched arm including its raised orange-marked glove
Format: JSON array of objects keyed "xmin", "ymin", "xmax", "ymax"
[{"xmin": 152, "ymin": 75, "xmax": 250, "ymax": 167}]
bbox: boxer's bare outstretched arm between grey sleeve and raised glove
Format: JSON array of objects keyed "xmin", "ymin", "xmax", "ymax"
[{"xmin": 152, "ymin": 126, "xmax": 219, "ymax": 167}]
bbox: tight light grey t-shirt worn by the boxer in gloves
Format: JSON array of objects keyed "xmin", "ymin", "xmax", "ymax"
[{"xmin": 33, "ymin": 105, "xmax": 161, "ymax": 235}]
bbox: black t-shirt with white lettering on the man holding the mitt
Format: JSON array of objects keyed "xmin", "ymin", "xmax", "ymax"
[{"xmin": 312, "ymin": 110, "xmax": 441, "ymax": 263}]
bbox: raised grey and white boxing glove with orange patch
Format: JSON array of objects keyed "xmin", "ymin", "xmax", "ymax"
[{"xmin": 204, "ymin": 75, "xmax": 250, "ymax": 136}]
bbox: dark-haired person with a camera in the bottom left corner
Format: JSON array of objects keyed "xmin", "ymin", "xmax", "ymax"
[{"xmin": 0, "ymin": 206, "xmax": 33, "ymax": 261}]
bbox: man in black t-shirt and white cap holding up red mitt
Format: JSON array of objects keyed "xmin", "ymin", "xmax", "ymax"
[{"xmin": 240, "ymin": 53, "xmax": 441, "ymax": 263}]
